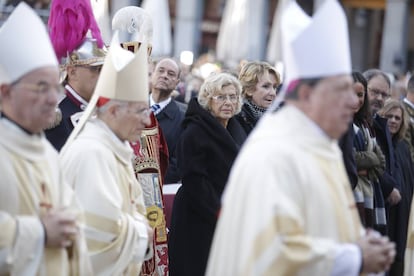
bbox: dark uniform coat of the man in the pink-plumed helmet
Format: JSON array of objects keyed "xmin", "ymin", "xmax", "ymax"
[{"xmin": 45, "ymin": 93, "xmax": 83, "ymax": 151}]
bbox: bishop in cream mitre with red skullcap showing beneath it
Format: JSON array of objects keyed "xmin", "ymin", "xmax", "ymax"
[{"xmin": 60, "ymin": 34, "xmax": 152, "ymax": 275}]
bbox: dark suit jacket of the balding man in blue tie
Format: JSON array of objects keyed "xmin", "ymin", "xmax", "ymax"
[{"xmin": 156, "ymin": 99, "xmax": 186, "ymax": 184}]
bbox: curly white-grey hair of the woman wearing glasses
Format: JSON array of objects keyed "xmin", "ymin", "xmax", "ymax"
[{"xmin": 198, "ymin": 72, "xmax": 243, "ymax": 114}]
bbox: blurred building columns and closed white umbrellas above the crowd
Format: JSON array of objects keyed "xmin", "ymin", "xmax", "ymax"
[{"xmin": 0, "ymin": 0, "xmax": 414, "ymax": 74}]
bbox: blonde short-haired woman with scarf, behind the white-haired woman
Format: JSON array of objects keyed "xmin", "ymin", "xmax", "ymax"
[{"xmin": 236, "ymin": 61, "xmax": 280, "ymax": 135}]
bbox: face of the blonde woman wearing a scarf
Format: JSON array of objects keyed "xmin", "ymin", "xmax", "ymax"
[{"xmin": 247, "ymin": 71, "xmax": 278, "ymax": 108}]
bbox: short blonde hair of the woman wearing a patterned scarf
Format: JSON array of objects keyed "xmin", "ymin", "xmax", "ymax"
[{"xmin": 239, "ymin": 61, "xmax": 280, "ymax": 99}]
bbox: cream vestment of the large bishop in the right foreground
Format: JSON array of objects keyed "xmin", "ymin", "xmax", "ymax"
[{"xmin": 206, "ymin": 106, "xmax": 363, "ymax": 276}]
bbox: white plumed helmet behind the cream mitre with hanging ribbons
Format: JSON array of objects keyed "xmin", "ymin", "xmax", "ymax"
[{"xmin": 112, "ymin": 6, "xmax": 153, "ymax": 56}]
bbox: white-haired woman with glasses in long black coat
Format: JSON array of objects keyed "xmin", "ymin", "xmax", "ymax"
[{"xmin": 169, "ymin": 73, "xmax": 246, "ymax": 276}]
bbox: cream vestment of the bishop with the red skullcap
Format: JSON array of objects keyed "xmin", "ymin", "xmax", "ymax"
[{"xmin": 61, "ymin": 119, "xmax": 148, "ymax": 275}]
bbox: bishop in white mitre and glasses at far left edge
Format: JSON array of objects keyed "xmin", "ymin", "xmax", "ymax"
[{"xmin": 0, "ymin": 2, "xmax": 91, "ymax": 276}]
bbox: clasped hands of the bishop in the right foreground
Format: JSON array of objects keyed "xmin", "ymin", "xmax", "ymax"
[{"xmin": 357, "ymin": 230, "xmax": 396, "ymax": 273}]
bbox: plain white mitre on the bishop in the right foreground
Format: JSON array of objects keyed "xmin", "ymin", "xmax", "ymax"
[{"xmin": 281, "ymin": 0, "xmax": 351, "ymax": 90}]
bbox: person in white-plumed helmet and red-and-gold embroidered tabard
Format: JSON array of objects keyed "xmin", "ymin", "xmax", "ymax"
[{"xmin": 112, "ymin": 6, "xmax": 168, "ymax": 276}]
